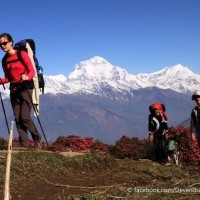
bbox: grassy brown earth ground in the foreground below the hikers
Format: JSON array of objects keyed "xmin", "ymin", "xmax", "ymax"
[{"xmin": 0, "ymin": 151, "xmax": 200, "ymax": 200}]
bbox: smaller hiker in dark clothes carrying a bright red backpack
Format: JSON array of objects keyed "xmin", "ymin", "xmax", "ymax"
[{"xmin": 148, "ymin": 103, "xmax": 168, "ymax": 164}]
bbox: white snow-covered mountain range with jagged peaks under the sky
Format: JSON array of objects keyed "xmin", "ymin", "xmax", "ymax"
[{"xmin": 45, "ymin": 56, "xmax": 200, "ymax": 95}]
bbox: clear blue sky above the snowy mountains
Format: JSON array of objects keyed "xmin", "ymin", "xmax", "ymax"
[{"xmin": 0, "ymin": 0, "xmax": 200, "ymax": 76}]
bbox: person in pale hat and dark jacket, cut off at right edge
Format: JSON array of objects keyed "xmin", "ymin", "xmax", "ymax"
[{"xmin": 190, "ymin": 91, "xmax": 200, "ymax": 147}]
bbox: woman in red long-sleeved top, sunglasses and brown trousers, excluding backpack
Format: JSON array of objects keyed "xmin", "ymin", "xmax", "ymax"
[{"xmin": 0, "ymin": 33, "xmax": 41, "ymax": 148}]
